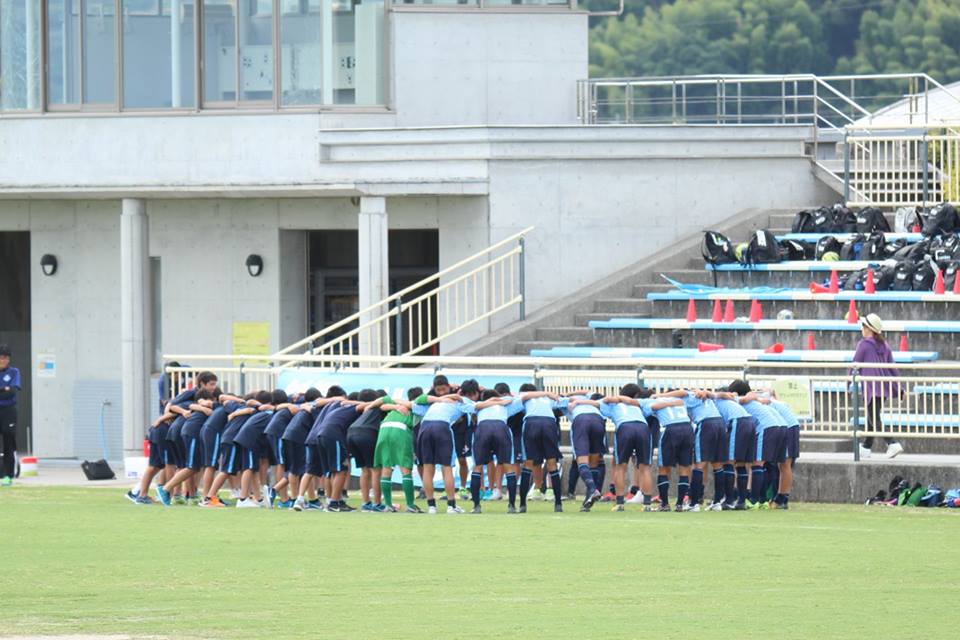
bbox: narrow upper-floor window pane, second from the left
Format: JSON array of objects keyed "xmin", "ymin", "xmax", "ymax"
[{"xmin": 47, "ymin": 0, "xmax": 80, "ymax": 105}]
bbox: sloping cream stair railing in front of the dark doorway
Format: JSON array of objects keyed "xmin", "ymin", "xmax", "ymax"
[{"xmin": 269, "ymin": 227, "xmax": 533, "ymax": 366}]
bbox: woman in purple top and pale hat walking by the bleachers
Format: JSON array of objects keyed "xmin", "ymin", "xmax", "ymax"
[{"xmin": 853, "ymin": 313, "xmax": 903, "ymax": 458}]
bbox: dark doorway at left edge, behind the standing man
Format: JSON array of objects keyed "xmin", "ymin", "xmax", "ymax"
[{"xmin": 0, "ymin": 231, "xmax": 33, "ymax": 455}]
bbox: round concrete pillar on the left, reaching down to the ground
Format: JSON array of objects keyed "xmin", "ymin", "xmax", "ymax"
[{"xmin": 120, "ymin": 198, "xmax": 150, "ymax": 456}]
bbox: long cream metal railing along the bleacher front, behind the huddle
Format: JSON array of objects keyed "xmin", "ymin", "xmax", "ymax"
[{"xmin": 164, "ymin": 354, "xmax": 960, "ymax": 454}]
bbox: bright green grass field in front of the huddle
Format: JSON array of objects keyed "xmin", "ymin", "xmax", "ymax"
[{"xmin": 0, "ymin": 487, "xmax": 960, "ymax": 640}]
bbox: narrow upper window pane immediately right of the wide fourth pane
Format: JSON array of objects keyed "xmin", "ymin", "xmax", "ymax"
[{"xmin": 203, "ymin": 0, "xmax": 237, "ymax": 102}]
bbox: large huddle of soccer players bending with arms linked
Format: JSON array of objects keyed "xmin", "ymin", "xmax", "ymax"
[{"xmin": 127, "ymin": 372, "xmax": 800, "ymax": 514}]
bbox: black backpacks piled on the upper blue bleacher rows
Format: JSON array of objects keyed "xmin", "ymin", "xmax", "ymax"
[{"xmin": 701, "ymin": 203, "xmax": 960, "ymax": 291}]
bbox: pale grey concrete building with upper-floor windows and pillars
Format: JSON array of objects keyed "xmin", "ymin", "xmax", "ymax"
[{"xmin": 0, "ymin": 0, "xmax": 836, "ymax": 457}]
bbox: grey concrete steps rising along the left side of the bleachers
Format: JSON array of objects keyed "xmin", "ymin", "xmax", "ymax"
[{"xmin": 460, "ymin": 208, "xmax": 800, "ymax": 355}]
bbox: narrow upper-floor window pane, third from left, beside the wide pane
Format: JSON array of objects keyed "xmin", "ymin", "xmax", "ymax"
[{"xmin": 83, "ymin": 0, "xmax": 117, "ymax": 104}]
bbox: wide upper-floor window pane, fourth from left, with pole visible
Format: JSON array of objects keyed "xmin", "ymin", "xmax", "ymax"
[{"xmin": 122, "ymin": 0, "xmax": 196, "ymax": 108}]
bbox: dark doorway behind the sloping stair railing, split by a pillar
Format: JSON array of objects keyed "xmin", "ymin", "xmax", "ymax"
[{"xmin": 307, "ymin": 229, "xmax": 440, "ymax": 349}]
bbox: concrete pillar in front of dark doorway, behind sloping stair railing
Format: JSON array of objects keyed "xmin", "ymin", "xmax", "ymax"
[{"xmin": 357, "ymin": 196, "xmax": 390, "ymax": 355}]
